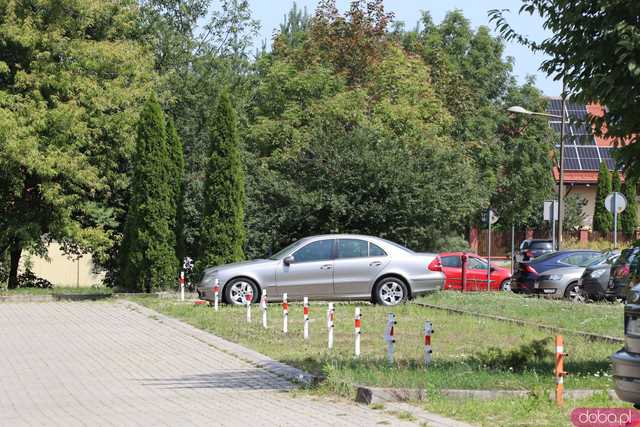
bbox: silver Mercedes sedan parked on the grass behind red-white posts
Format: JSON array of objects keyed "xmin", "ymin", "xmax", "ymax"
[{"xmin": 198, "ymin": 234, "xmax": 444, "ymax": 306}]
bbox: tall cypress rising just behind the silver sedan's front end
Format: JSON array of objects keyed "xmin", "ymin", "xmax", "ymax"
[{"xmin": 197, "ymin": 92, "xmax": 245, "ymax": 270}]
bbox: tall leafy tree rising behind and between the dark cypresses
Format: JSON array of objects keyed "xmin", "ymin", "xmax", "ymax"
[{"xmin": 141, "ymin": 0, "xmax": 259, "ymax": 258}]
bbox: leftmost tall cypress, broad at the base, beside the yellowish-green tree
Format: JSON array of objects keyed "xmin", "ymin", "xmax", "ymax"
[{"xmin": 120, "ymin": 97, "xmax": 177, "ymax": 292}]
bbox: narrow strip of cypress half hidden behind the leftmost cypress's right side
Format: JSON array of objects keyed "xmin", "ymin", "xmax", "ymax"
[{"xmin": 167, "ymin": 118, "xmax": 185, "ymax": 268}]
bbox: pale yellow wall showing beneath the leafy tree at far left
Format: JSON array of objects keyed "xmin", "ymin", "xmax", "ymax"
[{"xmin": 20, "ymin": 243, "xmax": 104, "ymax": 287}]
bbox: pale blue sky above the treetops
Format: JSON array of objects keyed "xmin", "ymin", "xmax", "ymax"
[{"xmin": 249, "ymin": 0, "xmax": 561, "ymax": 96}]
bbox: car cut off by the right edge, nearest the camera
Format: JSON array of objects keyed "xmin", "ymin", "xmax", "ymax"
[{"xmin": 611, "ymin": 284, "xmax": 640, "ymax": 408}]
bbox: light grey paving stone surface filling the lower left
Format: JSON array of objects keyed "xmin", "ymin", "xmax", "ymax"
[{"xmin": 0, "ymin": 302, "xmax": 436, "ymax": 427}]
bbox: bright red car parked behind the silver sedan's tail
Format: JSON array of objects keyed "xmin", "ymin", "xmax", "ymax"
[{"xmin": 438, "ymin": 252, "xmax": 511, "ymax": 291}]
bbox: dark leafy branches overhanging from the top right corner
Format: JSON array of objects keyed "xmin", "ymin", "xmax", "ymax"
[{"xmin": 490, "ymin": 0, "xmax": 640, "ymax": 178}]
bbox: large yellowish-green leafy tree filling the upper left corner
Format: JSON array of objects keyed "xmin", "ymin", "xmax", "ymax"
[{"xmin": 0, "ymin": 0, "xmax": 152, "ymax": 286}]
